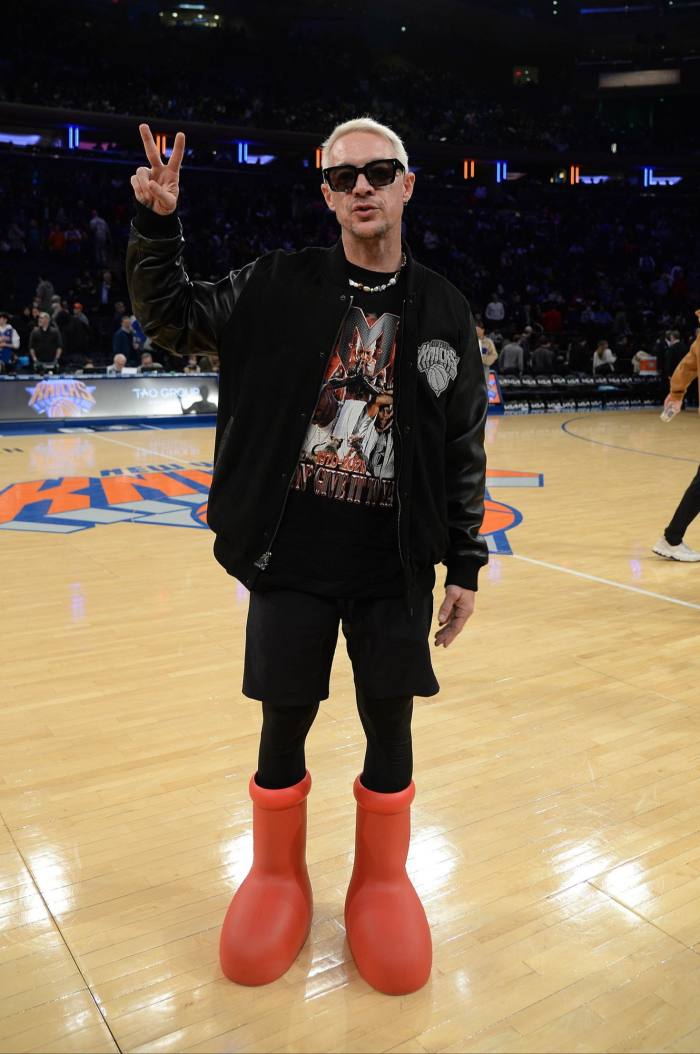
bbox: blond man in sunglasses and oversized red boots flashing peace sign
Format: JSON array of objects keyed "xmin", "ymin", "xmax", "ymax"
[{"xmin": 127, "ymin": 118, "xmax": 488, "ymax": 995}]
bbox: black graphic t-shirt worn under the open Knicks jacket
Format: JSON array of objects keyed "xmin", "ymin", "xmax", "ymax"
[{"xmin": 255, "ymin": 265, "xmax": 405, "ymax": 597}]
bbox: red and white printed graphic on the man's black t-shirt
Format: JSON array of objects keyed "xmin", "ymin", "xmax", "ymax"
[{"xmin": 292, "ymin": 307, "xmax": 400, "ymax": 508}]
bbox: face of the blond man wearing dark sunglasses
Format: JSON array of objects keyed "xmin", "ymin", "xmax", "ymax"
[{"xmin": 320, "ymin": 132, "xmax": 415, "ymax": 239}]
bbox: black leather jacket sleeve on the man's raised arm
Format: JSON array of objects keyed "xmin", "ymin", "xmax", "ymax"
[{"xmin": 127, "ymin": 203, "xmax": 255, "ymax": 354}]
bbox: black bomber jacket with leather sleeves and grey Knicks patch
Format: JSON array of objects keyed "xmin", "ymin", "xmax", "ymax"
[{"xmin": 127, "ymin": 203, "xmax": 488, "ymax": 604}]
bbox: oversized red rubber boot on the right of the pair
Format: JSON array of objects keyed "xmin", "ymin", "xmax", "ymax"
[{"xmin": 345, "ymin": 776, "xmax": 432, "ymax": 995}]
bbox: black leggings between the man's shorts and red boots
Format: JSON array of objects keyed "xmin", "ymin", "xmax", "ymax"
[{"xmin": 255, "ymin": 688, "xmax": 413, "ymax": 794}]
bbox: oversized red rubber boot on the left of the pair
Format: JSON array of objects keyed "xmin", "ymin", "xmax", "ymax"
[{"xmin": 219, "ymin": 769, "xmax": 313, "ymax": 984}]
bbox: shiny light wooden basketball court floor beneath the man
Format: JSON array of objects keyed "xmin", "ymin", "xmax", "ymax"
[{"xmin": 0, "ymin": 411, "xmax": 700, "ymax": 1054}]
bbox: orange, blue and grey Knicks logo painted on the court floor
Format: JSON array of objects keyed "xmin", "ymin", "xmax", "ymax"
[{"xmin": 0, "ymin": 462, "xmax": 543, "ymax": 553}]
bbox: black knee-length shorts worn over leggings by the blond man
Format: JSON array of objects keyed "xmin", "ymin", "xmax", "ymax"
[{"xmin": 242, "ymin": 589, "xmax": 440, "ymax": 706}]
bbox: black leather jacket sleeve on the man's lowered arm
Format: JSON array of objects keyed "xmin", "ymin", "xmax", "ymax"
[{"xmin": 444, "ymin": 301, "xmax": 488, "ymax": 589}]
